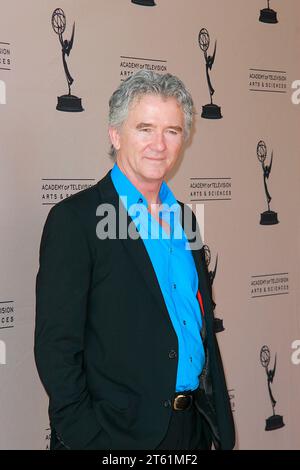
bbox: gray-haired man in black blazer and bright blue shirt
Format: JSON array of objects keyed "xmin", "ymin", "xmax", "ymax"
[{"xmin": 35, "ymin": 71, "xmax": 234, "ymax": 450}]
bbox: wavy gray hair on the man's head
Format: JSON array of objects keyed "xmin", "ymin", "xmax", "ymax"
[{"xmin": 109, "ymin": 70, "xmax": 194, "ymax": 158}]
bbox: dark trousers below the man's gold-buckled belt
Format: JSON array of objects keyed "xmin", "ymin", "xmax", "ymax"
[{"xmin": 157, "ymin": 404, "xmax": 211, "ymax": 450}]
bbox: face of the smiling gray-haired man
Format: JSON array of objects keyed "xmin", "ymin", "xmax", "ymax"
[{"xmin": 109, "ymin": 95, "xmax": 184, "ymax": 184}]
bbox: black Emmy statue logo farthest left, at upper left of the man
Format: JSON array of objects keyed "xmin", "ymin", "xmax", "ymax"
[{"xmin": 51, "ymin": 8, "xmax": 83, "ymax": 112}]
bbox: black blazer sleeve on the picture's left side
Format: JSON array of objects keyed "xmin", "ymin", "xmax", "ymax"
[{"xmin": 34, "ymin": 203, "xmax": 102, "ymax": 449}]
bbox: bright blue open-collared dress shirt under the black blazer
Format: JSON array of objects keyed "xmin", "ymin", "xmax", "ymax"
[{"xmin": 111, "ymin": 164, "xmax": 205, "ymax": 392}]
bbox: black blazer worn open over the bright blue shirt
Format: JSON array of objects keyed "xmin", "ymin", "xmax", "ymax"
[{"xmin": 34, "ymin": 172, "xmax": 234, "ymax": 449}]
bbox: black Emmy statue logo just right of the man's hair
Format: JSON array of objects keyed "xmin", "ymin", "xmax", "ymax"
[{"xmin": 198, "ymin": 28, "xmax": 223, "ymax": 119}]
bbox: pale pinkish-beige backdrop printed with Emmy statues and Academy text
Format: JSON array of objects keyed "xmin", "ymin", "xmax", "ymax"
[{"xmin": 0, "ymin": 0, "xmax": 300, "ymax": 449}]
